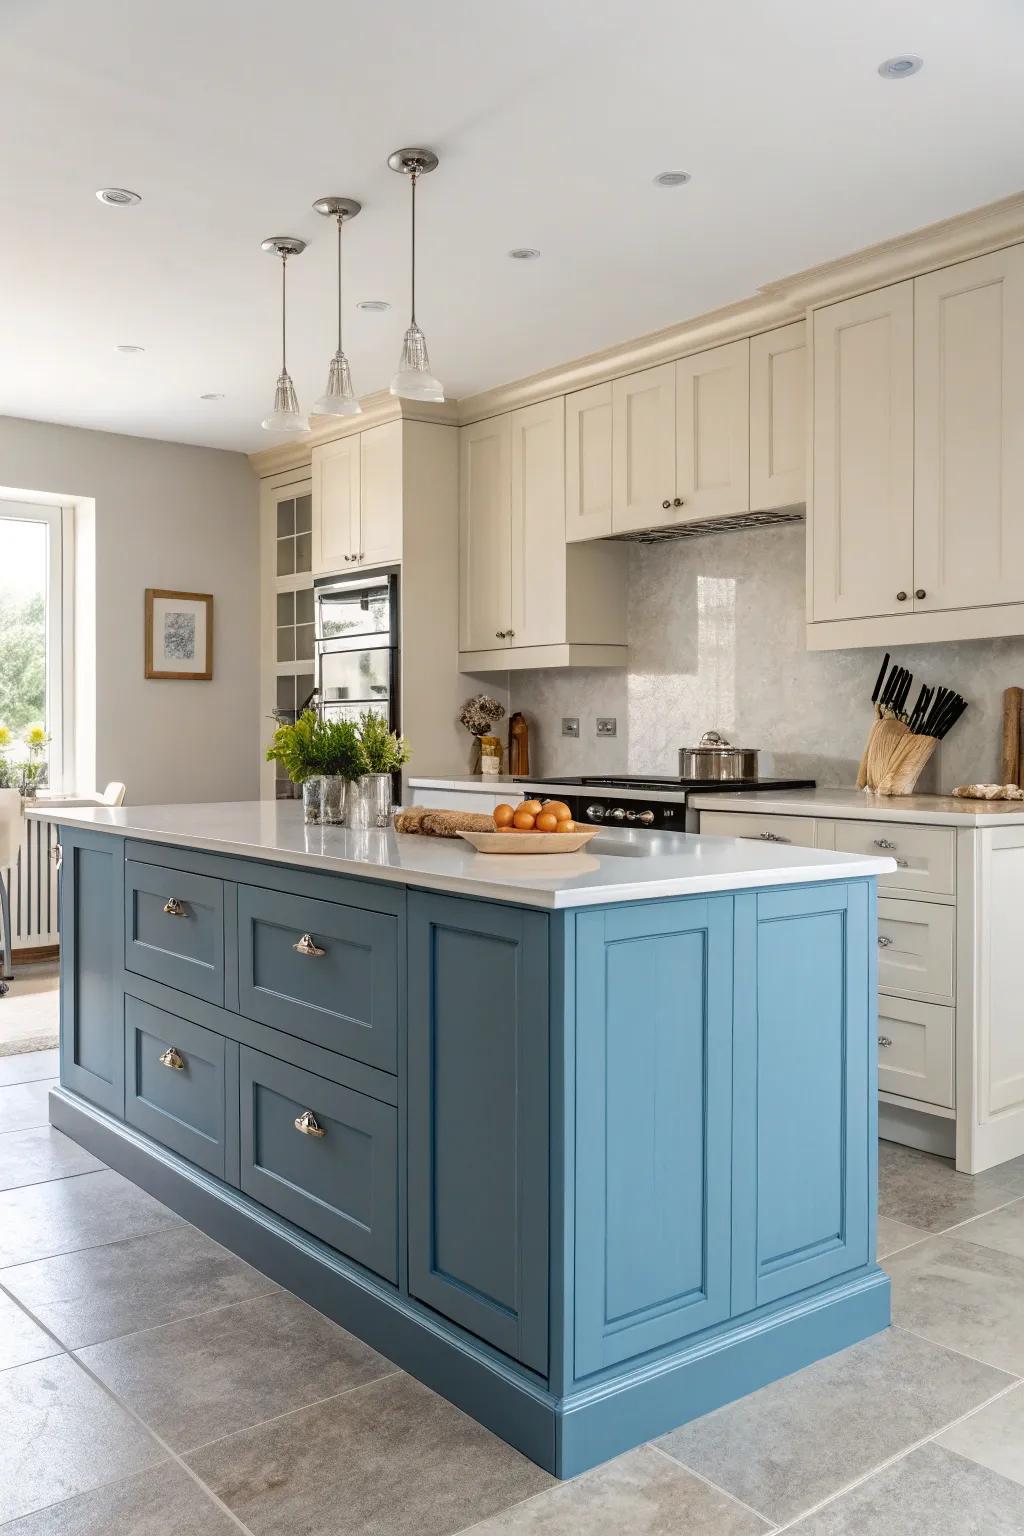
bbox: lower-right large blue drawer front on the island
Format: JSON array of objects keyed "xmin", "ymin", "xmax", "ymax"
[{"xmin": 239, "ymin": 1046, "xmax": 398, "ymax": 1283}]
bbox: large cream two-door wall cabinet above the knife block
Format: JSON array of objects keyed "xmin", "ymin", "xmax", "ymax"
[{"xmin": 808, "ymin": 246, "xmax": 1024, "ymax": 648}]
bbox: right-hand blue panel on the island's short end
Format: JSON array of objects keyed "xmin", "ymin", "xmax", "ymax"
[{"xmin": 732, "ymin": 880, "xmax": 875, "ymax": 1313}]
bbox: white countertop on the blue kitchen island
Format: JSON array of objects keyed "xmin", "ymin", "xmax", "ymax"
[{"xmin": 28, "ymin": 800, "xmax": 895, "ymax": 908}]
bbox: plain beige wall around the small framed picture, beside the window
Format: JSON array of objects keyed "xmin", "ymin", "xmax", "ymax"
[{"xmin": 0, "ymin": 416, "xmax": 259, "ymax": 805}]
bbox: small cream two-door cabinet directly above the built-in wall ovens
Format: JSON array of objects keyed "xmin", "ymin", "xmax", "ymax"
[{"xmin": 312, "ymin": 421, "xmax": 402, "ymax": 576}]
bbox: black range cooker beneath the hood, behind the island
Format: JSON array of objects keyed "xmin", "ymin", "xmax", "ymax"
[{"xmin": 516, "ymin": 774, "xmax": 814, "ymax": 833}]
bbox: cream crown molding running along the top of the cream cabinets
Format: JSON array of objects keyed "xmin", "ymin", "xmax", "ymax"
[{"xmin": 249, "ymin": 192, "xmax": 1024, "ymax": 476}]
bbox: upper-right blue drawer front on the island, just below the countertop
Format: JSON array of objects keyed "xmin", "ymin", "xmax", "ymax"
[{"xmin": 238, "ymin": 885, "xmax": 398, "ymax": 1072}]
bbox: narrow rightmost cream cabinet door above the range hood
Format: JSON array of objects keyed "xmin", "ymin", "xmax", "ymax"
[{"xmin": 751, "ymin": 319, "xmax": 808, "ymax": 511}]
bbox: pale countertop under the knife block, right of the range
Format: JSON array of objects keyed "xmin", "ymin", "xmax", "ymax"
[{"xmin": 689, "ymin": 790, "xmax": 1024, "ymax": 826}]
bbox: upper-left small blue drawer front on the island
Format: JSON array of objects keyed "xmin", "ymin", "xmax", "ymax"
[{"xmin": 124, "ymin": 859, "xmax": 224, "ymax": 1005}]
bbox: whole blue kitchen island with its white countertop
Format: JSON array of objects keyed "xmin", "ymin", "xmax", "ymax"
[{"xmin": 29, "ymin": 802, "xmax": 892, "ymax": 1476}]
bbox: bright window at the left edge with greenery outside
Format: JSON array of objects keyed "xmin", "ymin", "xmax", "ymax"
[{"xmin": 0, "ymin": 501, "xmax": 66, "ymax": 788}]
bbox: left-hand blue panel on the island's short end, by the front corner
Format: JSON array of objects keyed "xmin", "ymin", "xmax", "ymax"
[{"xmin": 576, "ymin": 897, "xmax": 732, "ymax": 1376}]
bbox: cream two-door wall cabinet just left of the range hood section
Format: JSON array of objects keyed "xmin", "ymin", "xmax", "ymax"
[{"xmin": 459, "ymin": 398, "xmax": 626, "ymax": 671}]
